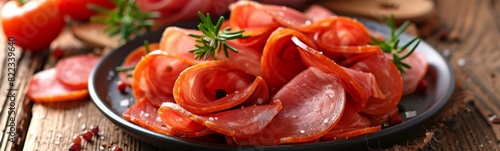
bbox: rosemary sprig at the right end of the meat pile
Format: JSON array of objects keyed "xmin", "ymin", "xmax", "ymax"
[{"xmin": 371, "ymin": 15, "xmax": 421, "ymax": 73}]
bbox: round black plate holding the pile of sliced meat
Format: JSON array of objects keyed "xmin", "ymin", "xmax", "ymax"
[{"xmin": 89, "ymin": 19, "xmax": 455, "ymax": 151}]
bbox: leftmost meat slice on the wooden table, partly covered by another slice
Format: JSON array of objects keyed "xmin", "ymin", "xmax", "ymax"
[{"xmin": 27, "ymin": 68, "xmax": 89, "ymax": 102}]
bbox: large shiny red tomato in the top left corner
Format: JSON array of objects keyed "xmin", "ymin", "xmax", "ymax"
[{"xmin": 1, "ymin": 0, "xmax": 65, "ymax": 51}]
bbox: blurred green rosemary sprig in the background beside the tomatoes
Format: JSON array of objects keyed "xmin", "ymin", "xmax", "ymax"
[{"xmin": 89, "ymin": 0, "xmax": 160, "ymax": 41}]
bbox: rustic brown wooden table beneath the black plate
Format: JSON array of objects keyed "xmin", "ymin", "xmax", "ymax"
[{"xmin": 0, "ymin": 0, "xmax": 500, "ymax": 151}]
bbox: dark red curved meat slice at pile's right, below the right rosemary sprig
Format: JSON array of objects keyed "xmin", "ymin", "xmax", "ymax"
[{"xmin": 351, "ymin": 54, "xmax": 403, "ymax": 115}]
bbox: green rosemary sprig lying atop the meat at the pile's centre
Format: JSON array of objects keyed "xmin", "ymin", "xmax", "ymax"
[{"xmin": 189, "ymin": 12, "xmax": 247, "ymax": 60}]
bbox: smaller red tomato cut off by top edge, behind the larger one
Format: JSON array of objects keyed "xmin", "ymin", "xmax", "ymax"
[{"xmin": 60, "ymin": 0, "xmax": 115, "ymax": 21}]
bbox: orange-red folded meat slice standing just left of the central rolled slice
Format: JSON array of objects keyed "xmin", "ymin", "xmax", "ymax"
[{"xmin": 132, "ymin": 50, "xmax": 195, "ymax": 106}]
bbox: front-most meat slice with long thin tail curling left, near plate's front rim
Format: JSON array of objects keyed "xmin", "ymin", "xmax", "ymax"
[{"xmin": 159, "ymin": 100, "xmax": 282, "ymax": 137}]
